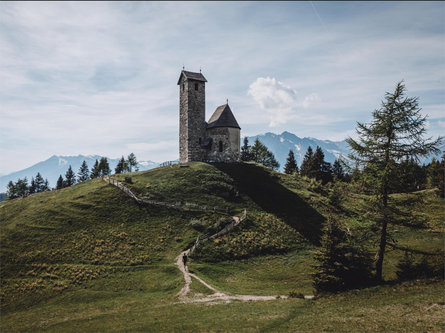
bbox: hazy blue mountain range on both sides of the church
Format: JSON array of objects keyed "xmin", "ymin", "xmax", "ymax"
[{"xmin": 0, "ymin": 131, "xmax": 445, "ymax": 192}]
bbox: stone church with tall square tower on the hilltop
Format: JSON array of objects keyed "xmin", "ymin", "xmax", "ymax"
[{"xmin": 178, "ymin": 70, "xmax": 241, "ymax": 163}]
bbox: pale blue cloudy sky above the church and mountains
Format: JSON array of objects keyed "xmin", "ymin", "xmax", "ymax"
[{"xmin": 0, "ymin": 1, "xmax": 445, "ymax": 174}]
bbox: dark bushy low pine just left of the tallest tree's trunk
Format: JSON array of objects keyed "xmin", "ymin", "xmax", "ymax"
[{"xmin": 312, "ymin": 216, "xmax": 373, "ymax": 292}]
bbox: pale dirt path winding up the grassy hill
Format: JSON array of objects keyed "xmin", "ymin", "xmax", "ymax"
[{"xmin": 103, "ymin": 176, "xmax": 314, "ymax": 303}]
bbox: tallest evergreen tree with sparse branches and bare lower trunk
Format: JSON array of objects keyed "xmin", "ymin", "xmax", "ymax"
[{"xmin": 347, "ymin": 82, "xmax": 442, "ymax": 280}]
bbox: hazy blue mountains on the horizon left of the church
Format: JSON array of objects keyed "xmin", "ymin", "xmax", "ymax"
[{"xmin": 0, "ymin": 155, "xmax": 159, "ymax": 192}]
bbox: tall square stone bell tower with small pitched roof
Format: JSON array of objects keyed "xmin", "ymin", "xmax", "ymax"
[{"xmin": 178, "ymin": 70, "xmax": 207, "ymax": 163}]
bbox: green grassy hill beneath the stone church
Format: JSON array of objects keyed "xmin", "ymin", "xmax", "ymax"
[{"xmin": 0, "ymin": 163, "xmax": 445, "ymax": 332}]
